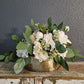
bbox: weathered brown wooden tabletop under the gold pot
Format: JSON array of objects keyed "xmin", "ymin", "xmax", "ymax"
[{"xmin": 0, "ymin": 62, "xmax": 84, "ymax": 79}]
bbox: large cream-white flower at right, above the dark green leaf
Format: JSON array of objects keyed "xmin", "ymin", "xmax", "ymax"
[{"xmin": 59, "ymin": 31, "xmax": 71, "ymax": 44}]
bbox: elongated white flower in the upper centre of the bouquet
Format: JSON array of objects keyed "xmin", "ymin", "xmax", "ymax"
[{"xmin": 44, "ymin": 33, "xmax": 55, "ymax": 51}]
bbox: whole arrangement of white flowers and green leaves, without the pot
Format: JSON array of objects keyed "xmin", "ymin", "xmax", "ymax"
[{"xmin": 0, "ymin": 17, "xmax": 84, "ymax": 74}]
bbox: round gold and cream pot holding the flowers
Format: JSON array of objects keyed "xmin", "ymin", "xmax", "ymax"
[{"xmin": 25, "ymin": 58, "xmax": 60, "ymax": 72}]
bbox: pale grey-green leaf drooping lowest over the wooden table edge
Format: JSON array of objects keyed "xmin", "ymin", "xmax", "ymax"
[{"xmin": 14, "ymin": 58, "xmax": 25, "ymax": 74}]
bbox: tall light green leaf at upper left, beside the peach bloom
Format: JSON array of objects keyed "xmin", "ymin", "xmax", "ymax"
[{"xmin": 23, "ymin": 25, "xmax": 32, "ymax": 43}]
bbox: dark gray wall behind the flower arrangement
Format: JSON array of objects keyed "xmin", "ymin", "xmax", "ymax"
[{"xmin": 0, "ymin": 0, "xmax": 84, "ymax": 60}]
